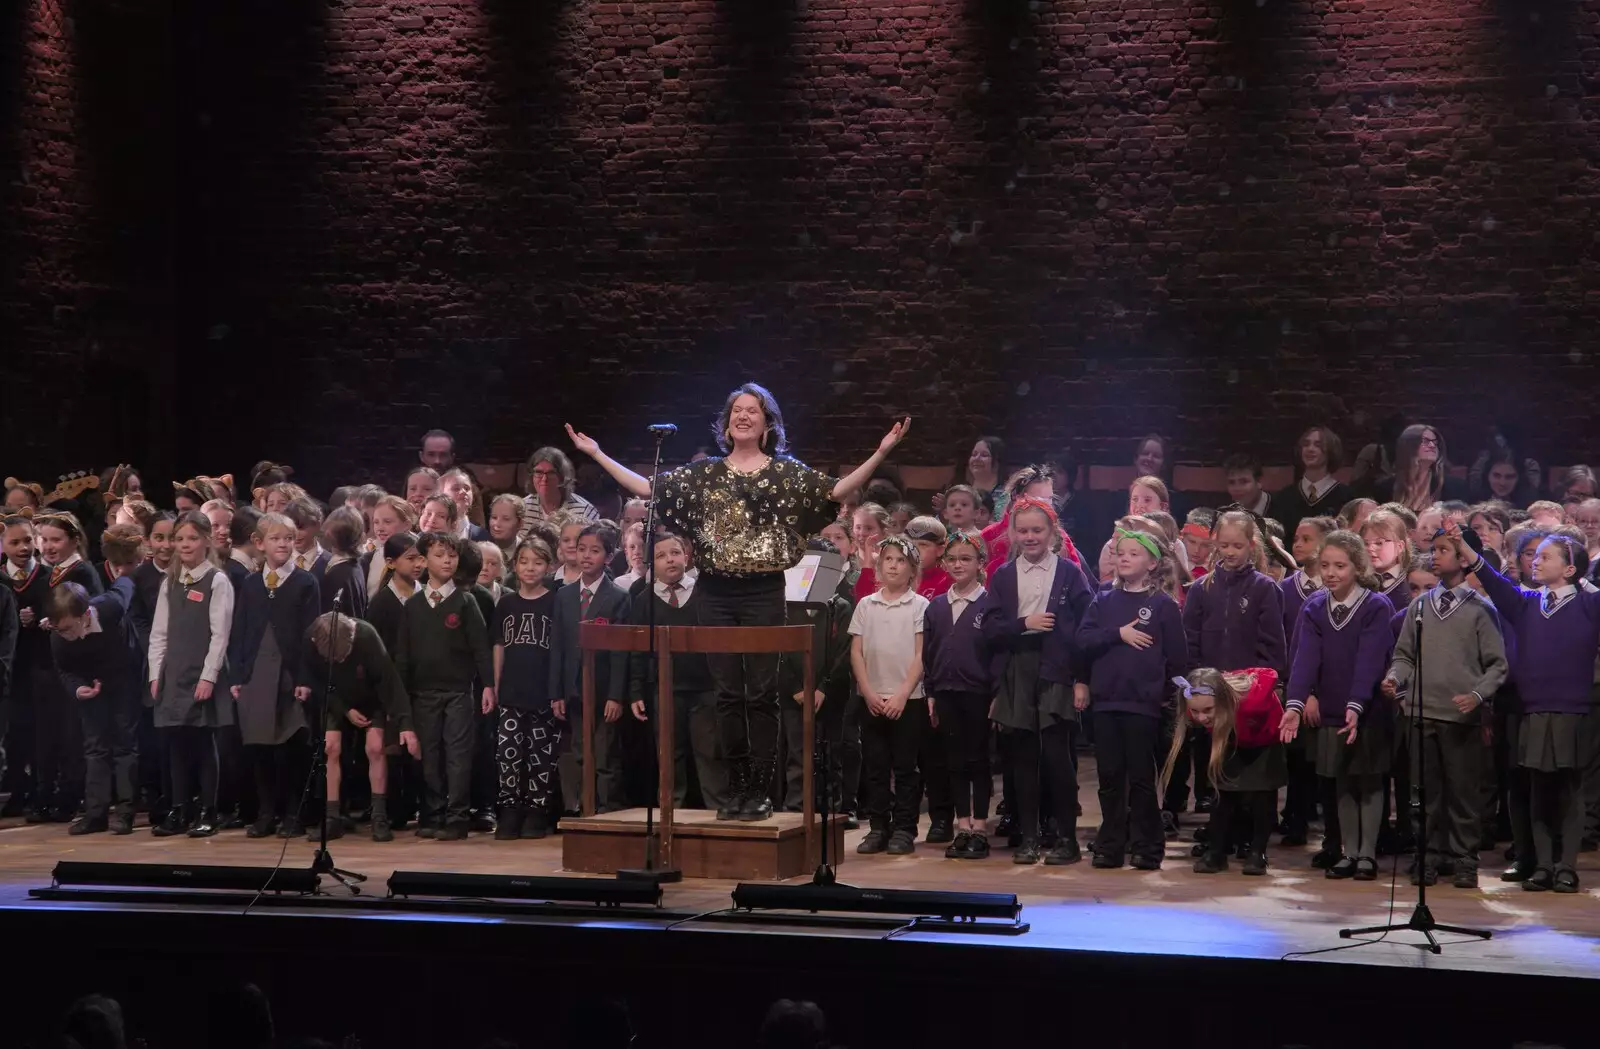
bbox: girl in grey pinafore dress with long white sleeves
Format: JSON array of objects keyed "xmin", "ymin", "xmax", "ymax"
[{"xmin": 147, "ymin": 510, "xmax": 234, "ymax": 838}]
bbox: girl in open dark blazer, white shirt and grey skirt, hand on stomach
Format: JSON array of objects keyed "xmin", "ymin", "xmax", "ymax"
[{"xmin": 984, "ymin": 496, "xmax": 1093, "ymax": 865}]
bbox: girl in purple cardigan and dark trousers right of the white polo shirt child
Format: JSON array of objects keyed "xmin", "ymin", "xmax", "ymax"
[{"xmin": 923, "ymin": 531, "xmax": 994, "ymax": 860}]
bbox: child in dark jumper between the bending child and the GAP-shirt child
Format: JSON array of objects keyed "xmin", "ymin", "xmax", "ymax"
[{"xmin": 395, "ymin": 532, "xmax": 494, "ymax": 841}]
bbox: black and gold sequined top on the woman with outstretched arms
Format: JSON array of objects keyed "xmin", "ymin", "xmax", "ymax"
[{"xmin": 656, "ymin": 456, "xmax": 838, "ymax": 576}]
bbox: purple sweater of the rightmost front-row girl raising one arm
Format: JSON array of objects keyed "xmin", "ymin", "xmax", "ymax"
[{"xmin": 1474, "ymin": 560, "xmax": 1600, "ymax": 713}]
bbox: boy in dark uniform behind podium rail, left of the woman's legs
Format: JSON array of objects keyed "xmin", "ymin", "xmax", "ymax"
[{"xmin": 627, "ymin": 534, "xmax": 728, "ymax": 809}]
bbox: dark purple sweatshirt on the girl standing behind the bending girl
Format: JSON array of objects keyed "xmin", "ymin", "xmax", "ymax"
[{"xmin": 1184, "ymin": 564, "xmax": 1288, "ymax": 675}]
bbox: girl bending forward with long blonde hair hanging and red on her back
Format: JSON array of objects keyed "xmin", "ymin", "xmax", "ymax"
[{"xmin": 1162, "ymin": 667, "xmax": 1288, "ymax": 876}]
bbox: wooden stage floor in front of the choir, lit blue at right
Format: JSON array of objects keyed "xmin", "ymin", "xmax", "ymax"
[{"xmin": 0, "ymin": 760, "xmax": 1600, "ymax": 977}]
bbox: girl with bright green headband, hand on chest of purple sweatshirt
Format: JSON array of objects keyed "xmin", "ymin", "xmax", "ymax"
[{"xmin": 1078, "ymin": 528, "xmax": 1189, "ymax": 870}]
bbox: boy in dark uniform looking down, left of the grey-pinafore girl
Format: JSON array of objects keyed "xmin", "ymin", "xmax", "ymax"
[{"xmin": 50, "ymin": 566, "xmax": 144, "ymax": 835}]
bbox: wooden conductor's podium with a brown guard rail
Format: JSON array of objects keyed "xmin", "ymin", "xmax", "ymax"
[{"xmin": 560, "ymin": 622, "xmax": 843, "ymax": 879}]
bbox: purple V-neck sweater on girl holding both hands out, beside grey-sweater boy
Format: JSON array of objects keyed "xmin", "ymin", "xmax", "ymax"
[{"xmin": 1286, "ymin": 590, "xmax": 1395, "ymax": 724}]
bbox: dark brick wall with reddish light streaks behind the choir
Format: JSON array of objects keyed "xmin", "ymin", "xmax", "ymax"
[{"xmin": 0, "ymin": 0, "xmax": 1600, "ymax": 489}]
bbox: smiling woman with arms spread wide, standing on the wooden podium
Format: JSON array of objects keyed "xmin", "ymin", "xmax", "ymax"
[{"xmin": 566, "ymin": 382, "xmax": 910, "ymax": 820}]
